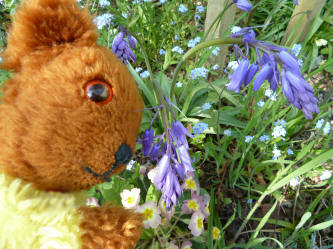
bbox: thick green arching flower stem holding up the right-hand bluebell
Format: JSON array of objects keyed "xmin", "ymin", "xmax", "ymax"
[{"xmin": 170, "ymin": 38, "xmax": 243, "ymax": 100}]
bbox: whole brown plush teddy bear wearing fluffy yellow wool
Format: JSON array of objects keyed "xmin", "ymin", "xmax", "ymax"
[{"xmin": 0, "ymin": 0, "xmax": 143, "ymax": 249}]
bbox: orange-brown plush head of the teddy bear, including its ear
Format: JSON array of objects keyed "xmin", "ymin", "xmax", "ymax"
[{"xmin": 0, "ymin": 0, "xmax": 143, "ymax": 191}]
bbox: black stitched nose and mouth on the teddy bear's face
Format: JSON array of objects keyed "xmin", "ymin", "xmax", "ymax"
[{"xmin": 83, "ymin": 144, "xmax": 133, "ymax": 182}]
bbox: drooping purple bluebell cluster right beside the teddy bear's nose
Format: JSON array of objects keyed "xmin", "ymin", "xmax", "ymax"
[{"xmin": 138, "ymin": 97, "xmax": 194, "ymax": 210}]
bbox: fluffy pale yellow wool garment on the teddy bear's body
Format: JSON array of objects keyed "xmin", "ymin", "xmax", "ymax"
[{"xmin": 0, "ymin": 171, "xmax": 86, "ymax": 249}]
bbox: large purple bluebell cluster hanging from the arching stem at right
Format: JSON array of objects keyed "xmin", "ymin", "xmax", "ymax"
[{"xmin": 228, "ymin": 28, "xmax": 319, "ymax": 119}]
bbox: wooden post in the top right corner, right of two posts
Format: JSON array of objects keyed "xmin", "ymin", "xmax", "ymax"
[{"xmin": 282, "ymin": 0, "xmax": 326, "ymax": 46}]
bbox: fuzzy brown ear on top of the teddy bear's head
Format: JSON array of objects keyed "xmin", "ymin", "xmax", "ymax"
[{"xmin": 1, "ymin": 0, "xmax": 97, "ymax": 71}]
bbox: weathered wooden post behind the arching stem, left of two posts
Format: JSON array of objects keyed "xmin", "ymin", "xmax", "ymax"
[{"xmin": 205, "ymin": 0, "xmax": 236, "ymax": 68}]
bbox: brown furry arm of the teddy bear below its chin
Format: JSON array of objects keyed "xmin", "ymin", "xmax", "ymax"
[{"xmin": 81, "ymin": 205, "xmax": 142, "ymax": 249}]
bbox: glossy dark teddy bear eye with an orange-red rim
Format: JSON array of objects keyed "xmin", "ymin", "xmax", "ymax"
[{"xmin": 84, "ymin": 80, "xmax": 113, "ymax": 105}]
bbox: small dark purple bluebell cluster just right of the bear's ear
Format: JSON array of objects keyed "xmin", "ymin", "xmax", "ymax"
[{"xmin": 112, "ymin": 27, "xmax": 136, "ymax": 64}]
